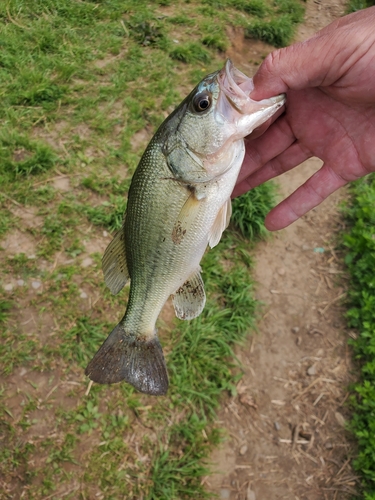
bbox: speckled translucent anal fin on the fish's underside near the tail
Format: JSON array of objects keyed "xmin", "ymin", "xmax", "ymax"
[{"xmin": 172, "ymin": 269, "xmax": 206, "ymax": 319}]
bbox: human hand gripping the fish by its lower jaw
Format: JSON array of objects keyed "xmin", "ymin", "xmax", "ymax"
[{"xmin": 233, "ymin": 7, "xmax": 375, "ymax": 230}]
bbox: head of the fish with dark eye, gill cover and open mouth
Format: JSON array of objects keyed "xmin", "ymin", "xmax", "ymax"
[{"xmin": 178, "ymin": 59, "xmax": 285, "ymax": 178}]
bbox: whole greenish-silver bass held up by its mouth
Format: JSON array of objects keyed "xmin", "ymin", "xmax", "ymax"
[{"xmin": 85, "ymin": 60, "xmax": 285, "ymax": 396}]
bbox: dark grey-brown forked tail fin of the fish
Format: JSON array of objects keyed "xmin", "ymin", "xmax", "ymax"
[{"xmin": 85, "ymin": 323, "xmax": 168, "ymax": 396}]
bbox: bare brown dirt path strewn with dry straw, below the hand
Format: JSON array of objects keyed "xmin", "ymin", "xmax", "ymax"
[{"xmin": 206, "ymin": 0, "xmax": 357, "ymax": 500}]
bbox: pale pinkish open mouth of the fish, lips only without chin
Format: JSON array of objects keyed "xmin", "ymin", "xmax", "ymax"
[{"xmin": 218, "ymin": 59, "xmax": 285, "ymax": 114}]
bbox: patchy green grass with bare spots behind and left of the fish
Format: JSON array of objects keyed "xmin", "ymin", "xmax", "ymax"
[{"xmin": 0, "ymin": 0, "xmax": 306, "ymax": 500}]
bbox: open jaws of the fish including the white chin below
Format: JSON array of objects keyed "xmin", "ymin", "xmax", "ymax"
[{"xmin": 217, "ymin": 59, "xmax": 286, "ymax": 140}]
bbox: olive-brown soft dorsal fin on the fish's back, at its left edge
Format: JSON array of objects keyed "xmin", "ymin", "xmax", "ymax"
[{"xmin": 102, "ymin": 227, "xmax": 129, "ymax": 295}]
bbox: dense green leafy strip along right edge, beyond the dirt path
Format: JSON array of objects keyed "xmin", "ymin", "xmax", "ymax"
[{"xmin": 343, "ymin": 175, "xmax": 375, "ymax": 499}]
